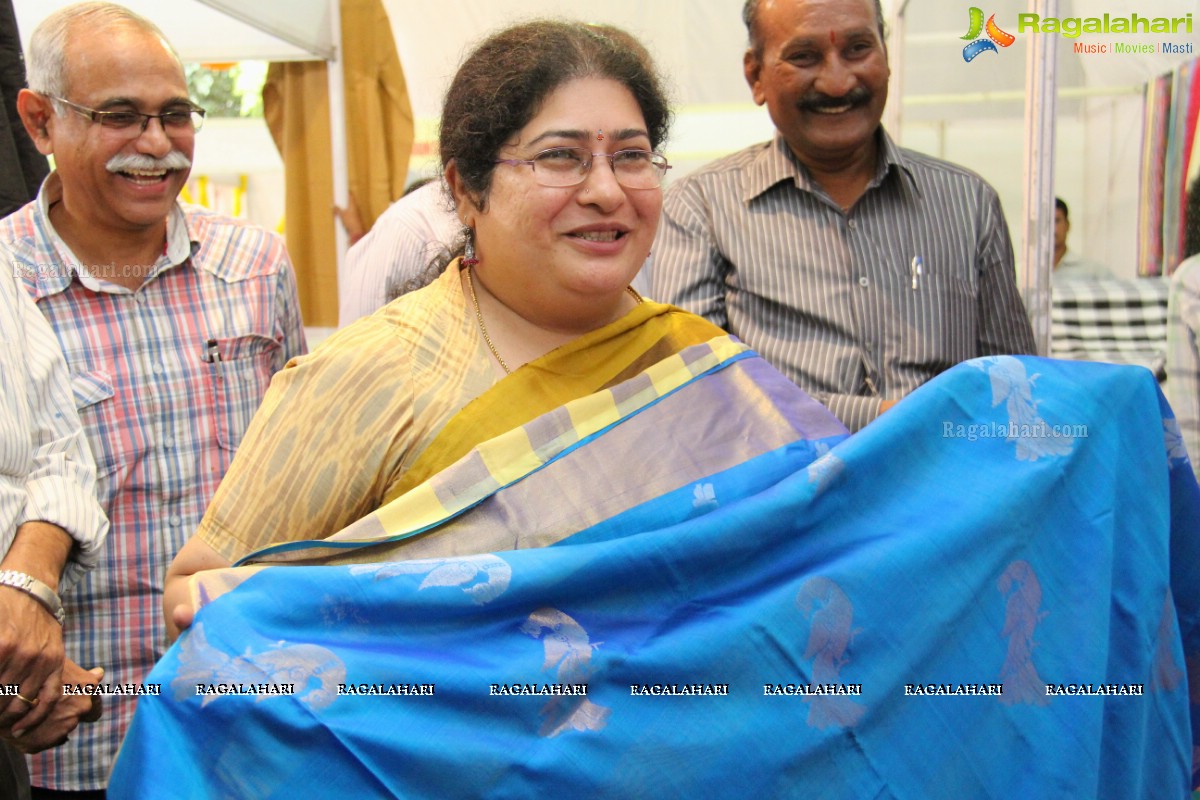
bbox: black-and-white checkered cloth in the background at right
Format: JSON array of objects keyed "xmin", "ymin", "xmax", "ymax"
[{"xmin": 1050, "ymin": 278, "xmax": 1168, "ymax": 380}]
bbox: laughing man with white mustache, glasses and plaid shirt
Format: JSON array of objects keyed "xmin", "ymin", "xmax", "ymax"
[{"xmin": 0, "ymin": 2, "xmax": 305, "ymax": 798}]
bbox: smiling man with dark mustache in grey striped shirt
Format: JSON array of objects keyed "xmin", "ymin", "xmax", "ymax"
[{"xmin": 650, "ymin": 0, "xmax": 1034, "ymax": 431}]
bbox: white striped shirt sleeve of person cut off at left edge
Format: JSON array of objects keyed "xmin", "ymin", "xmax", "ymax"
[{"xmin": 0, "ymin": 268, "xmax": 108, "ymax": 587}]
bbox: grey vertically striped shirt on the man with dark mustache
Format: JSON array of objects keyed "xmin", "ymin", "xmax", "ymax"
[{"xmin": 650, "ymin": 128, "xmax": 1034, "ymax": 431}]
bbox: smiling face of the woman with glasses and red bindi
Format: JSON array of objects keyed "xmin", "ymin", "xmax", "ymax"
[{"xmin": 460, "ymin": 77, "xmax": 662, "ymax": 327}]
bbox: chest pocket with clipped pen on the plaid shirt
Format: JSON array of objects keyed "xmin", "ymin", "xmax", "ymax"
[{"xmin": 204, "ymin": 333, "xmax": 280, "ymax": 451}]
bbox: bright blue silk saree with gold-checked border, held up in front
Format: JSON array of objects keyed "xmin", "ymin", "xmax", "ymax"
[{"xmin": 108, "ymin": 338, "xmax": 1200, "ymax": 800}]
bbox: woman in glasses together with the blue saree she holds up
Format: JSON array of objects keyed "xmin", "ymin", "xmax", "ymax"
[{"xmin": 142, "ymin": 23, "xmax": 1200, "ymax": 800}]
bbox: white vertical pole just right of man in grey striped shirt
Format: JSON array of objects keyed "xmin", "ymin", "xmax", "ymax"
[{"xmin": 1016, "ymin": 0, "xmax": 1058, "ymax": 355}]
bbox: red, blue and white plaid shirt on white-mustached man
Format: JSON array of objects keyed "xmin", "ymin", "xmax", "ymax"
[{"xmin": 0, "ymin": 174, "xmax": 305, "ymax": 790}]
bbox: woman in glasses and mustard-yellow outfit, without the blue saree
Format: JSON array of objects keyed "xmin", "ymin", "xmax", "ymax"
[{"xmin": 164, "ymin": 22, "xmax": 772, "ymax": 619}]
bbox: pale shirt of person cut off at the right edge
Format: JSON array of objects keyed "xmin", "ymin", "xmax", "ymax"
[{"xmin": 1166, "ymin": 255, "xmax": 1200, "ymax": 479}]
